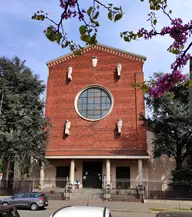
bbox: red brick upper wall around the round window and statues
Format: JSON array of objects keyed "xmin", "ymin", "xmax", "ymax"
[{"xmin": 46, "ymin": 49, "xmax": 146, "ymax": 155}]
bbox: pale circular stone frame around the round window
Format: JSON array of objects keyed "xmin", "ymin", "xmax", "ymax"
[{"xmin": 74, "ymin": 84, "xmax": 114, "ymax": 122}]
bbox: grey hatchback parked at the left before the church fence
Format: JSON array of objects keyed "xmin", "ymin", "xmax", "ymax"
[{"xmin": 0, "ymin": 192, "xmax": 48, "ymax": 210}]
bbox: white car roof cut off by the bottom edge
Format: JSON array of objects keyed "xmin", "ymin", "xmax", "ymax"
[{"xmin": 50, "ymin": 206, "xmax": 112, "ymax": 217}]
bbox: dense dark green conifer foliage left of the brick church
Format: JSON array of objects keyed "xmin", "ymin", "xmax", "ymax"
[{"xmin": 0, "ymin": 57, "xmax": 48, "ymax": 179}]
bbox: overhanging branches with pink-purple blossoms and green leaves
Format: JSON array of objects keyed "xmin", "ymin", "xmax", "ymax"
[{"xmin": 32, "ymin": 0, "xmax": 192, "ymax": 97}]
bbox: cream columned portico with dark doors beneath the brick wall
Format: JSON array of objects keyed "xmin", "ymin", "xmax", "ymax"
[{"xmin": 40, "ymin": 156, "xmax": 148, "ymax": 188}]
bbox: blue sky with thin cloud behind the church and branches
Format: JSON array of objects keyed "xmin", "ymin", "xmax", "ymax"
[{"xmin": 0, "ymin": 0, "xmax": 192, "ymax": 94}]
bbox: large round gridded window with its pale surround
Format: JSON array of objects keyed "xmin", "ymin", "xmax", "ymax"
[{"xmin": 75, "ymin": 85, "xmax": 113, "ymax": 121}]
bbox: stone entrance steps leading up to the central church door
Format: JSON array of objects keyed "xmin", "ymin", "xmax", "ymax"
[{"xmin": 71, "ymin": 188, "xmax": 103, "ymax": 201}]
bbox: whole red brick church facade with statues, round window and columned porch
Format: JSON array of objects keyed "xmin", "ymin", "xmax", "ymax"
[{"xmin": 41, "ymin": 44, "xmax": 149, "ymax": 188}]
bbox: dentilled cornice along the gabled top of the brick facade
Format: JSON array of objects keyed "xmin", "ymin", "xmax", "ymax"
[{"xmin": 46, "ymin": 44, "xmax": 147, "ymax": 67}]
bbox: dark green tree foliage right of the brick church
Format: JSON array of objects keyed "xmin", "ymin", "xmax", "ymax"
[{"xmin": 141, "ymin": 74, "xmax": 192, "ymax": 169}]
